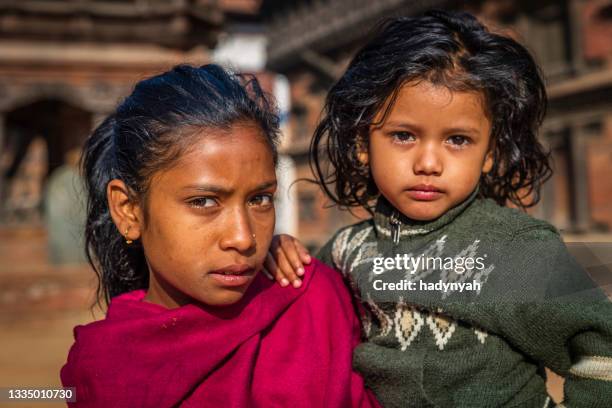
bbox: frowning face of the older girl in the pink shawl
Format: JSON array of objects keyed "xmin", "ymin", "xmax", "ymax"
[{"xmin": 110, "ymin": 125, "xmax": 276, "ymax": 308}]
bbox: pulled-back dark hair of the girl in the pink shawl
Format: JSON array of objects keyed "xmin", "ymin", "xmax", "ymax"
[{"xmin": 82, "ymin": 65, "xmax": 279, "ymax": 304}]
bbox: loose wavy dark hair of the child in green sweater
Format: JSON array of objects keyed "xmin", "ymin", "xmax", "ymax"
[{"xmin": 310, "ymin": 11, "xmax": 552, "ymax": 211}]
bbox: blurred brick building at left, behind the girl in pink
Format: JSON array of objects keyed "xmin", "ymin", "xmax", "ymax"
[{"xmin": 0, "ymin": 0, "xmax": 259, "ymax": 224}]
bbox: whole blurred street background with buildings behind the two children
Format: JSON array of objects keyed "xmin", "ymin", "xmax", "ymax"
[{"xmin": 0, "ymin": 0, "xmax": 612, "ymax": 406}]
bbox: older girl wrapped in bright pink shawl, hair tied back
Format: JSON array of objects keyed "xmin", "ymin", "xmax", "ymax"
[{"xmin": 61, "ymin": 65, "xmax": 377, "ymax": 407}]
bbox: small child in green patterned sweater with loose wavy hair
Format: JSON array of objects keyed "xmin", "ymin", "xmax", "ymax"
[{"xmin": 267, "ymin": 11, "xmax": 612, "ymax": 408}]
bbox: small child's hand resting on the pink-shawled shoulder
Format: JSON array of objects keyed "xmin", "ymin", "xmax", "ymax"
[{"xmin": 264, "ymin": 234, "xmax": 310, "ymax": 288}]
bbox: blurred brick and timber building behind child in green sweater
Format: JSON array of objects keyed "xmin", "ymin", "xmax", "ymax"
[{"xmin": 261, "ymin": 0, "xmax": 612, "ymax": 246}]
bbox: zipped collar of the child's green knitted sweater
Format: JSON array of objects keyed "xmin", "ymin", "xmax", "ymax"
[{"xmin": 374, "ymin": 186, "xmax": 479, "ymax": 243}]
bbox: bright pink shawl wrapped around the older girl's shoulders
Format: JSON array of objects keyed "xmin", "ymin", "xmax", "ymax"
[{"xmin": 61, "ymin": 260, "xmax": 378, "ymax": 408}]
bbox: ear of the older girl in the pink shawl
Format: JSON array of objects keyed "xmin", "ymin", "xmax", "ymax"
[{"xmin": 106, "ymin": 179, "xmax": 143, "ymax": 242}]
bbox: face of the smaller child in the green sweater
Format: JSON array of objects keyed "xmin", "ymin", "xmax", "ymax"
[{"xmin": 368, "ymin": 81, "xmax": 492, "ymax": 221}]
